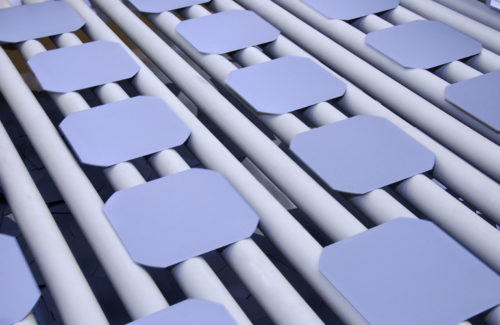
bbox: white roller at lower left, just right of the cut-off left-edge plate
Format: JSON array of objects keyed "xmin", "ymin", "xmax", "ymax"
[{"xmin": 0, "ymin": 120, "xmax": 108, "ymax": 325}]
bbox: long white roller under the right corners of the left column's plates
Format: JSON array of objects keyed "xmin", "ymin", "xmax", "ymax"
[{"xmin": 64, "ymin": 0, "xmax": 366, "ymax": 324}]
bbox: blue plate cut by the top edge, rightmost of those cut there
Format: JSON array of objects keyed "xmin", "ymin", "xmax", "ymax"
[{"xmin": 301, "ymin": 0, "xmax": 399, "ymax": 20}]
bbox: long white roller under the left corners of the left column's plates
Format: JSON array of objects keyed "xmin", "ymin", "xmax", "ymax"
[{"xmin": 0, "ymin": 41, "xmax": 167, "ymax": 318}]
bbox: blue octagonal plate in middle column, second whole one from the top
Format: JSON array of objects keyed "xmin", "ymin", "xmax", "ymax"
[{"xmin": 226, "ymin": 56, "xmax": 346, "ymax": 114}]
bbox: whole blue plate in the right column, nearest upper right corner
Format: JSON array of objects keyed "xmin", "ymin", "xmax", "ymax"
[{"xmin": 365, "ymin": 20, "xmax": 482, "ymax": 69}]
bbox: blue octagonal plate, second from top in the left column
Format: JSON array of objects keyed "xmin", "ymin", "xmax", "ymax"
[{"xmin": 28, "ymin": 41, "xmax": 139, "ymax": 93}]
